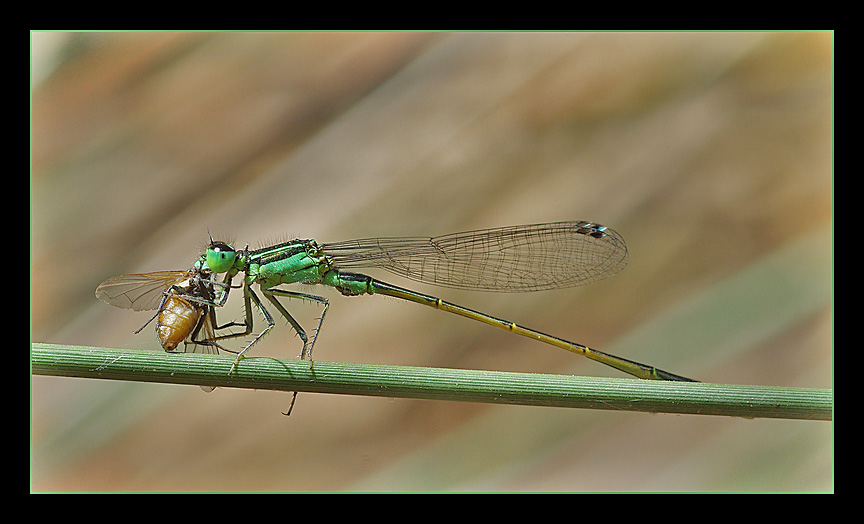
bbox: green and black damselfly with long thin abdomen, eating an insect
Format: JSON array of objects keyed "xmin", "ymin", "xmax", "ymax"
[{"xmin": 196, "ymin": 222, "xmax": 692, "ymax": 382}]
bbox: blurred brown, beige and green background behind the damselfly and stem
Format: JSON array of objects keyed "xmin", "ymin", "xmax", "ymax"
[{"xmin": 30, "ymin": 33, "xmax": 834, "ymax": 491}]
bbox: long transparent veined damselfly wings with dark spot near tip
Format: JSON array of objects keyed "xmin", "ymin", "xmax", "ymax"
[{"xmin": 321, "ymin": 222, "xmax": 628, "ymax": 292}]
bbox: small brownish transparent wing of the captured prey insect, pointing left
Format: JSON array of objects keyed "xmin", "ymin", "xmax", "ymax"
[{"xmin": 96, "ymin": 271, "xmax": 189, "ymax": 311}]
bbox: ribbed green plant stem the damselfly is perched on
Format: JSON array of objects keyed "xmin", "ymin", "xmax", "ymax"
[{"xmin": 30, "ymin": 342, "xmax": 833, "ymax": 420}]
